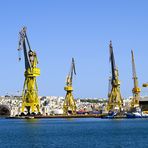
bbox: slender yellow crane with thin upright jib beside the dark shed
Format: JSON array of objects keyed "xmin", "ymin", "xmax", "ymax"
[{"xmin": 131, "ymin": 50, "xmax": 141, "ymax": 109}]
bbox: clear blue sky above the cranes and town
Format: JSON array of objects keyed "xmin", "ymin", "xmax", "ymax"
[{"xmin": 0, "ymin": 0, "xmax": 148, "ymax": 98}]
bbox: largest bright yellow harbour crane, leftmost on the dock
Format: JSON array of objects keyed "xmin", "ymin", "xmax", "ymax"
[{"xmin": 18, "ymin": 27, "xmax": 40, "ymax": 115}]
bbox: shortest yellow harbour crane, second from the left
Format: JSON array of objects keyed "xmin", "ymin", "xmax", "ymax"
[{"xmin": 63, "ymin": 58, "xmax": 76, "ymax": 114}]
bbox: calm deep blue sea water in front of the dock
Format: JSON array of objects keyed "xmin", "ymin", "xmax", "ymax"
[{"xmin": 0, "ymin": 118, "xmax": 148, "ymax": 148}]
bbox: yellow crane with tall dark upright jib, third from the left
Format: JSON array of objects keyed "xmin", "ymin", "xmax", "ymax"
[{"xmin": 107, "ymin": 41, "xmax": 123, "ymax": 112}]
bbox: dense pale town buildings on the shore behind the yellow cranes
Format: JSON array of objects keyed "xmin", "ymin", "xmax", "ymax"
[{"xmin": 0, "ymin": 95, "xmax": 148, "ymax": 117}]
